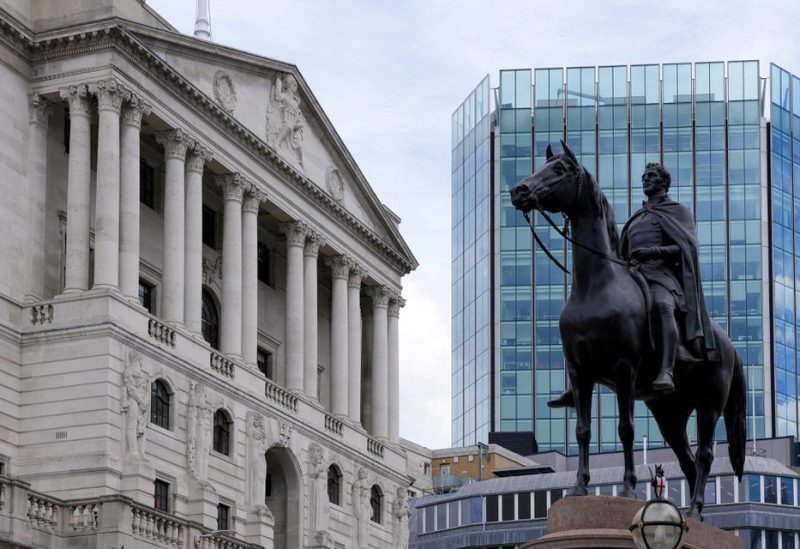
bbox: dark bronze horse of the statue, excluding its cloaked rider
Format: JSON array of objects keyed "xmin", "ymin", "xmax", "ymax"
[{"xmin": 511, "ymin": 141, "xmax": 746, "ymax": 519}]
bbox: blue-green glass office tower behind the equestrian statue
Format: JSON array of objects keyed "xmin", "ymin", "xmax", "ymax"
[{"xmin": 452, "ymin": 61, "xmax": 800, "ymax": 453}]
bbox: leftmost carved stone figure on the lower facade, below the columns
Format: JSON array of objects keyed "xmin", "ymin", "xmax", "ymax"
[{"xmin": 121, "ymin": 352, "xmax": 150, "ymax": 461}]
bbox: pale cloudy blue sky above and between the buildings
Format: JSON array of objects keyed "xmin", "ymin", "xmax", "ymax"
[{"xmin": 148, "ymin": 0, "xmax": 800, "ymax": 448}]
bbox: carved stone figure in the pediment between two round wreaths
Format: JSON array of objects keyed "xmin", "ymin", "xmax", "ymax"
[{"xmin": 267, "ymin": 74, "xmax": 304, "ymax": 166}]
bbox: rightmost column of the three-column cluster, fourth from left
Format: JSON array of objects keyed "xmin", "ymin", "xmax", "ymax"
[{"xmin": 119, "ymin": 96, "xmax": 150, "ymax": 303}]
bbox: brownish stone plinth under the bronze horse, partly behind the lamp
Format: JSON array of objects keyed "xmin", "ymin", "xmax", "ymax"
[{"xmin": 521, "ymin": 496, "xmax": 742, "ymax": 549}]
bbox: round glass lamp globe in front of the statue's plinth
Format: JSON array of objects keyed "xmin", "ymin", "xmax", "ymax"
[{"xmin": 630, "ymin": 499, "xmax": 688, "ymax": 549}]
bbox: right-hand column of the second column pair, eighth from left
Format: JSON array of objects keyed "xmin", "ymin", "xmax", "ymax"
[{"xmin": 242, "ymin": 184, "xmax": 266, "ymax": 366}]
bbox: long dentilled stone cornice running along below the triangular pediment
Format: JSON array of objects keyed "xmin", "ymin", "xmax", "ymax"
[{"xmin": 0, "ymin": 16, "xmax": 418, "ymax": 274}]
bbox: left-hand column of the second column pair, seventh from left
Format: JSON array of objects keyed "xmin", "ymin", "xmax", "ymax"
[{"xmin": 219, "ymin": 174, "xmax": 246, "ymax": 357}]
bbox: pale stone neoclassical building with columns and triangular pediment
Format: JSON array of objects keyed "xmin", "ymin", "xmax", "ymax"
[{"xmin": 0, "ymin": 0, "xmax": 419, "ymax": 549}]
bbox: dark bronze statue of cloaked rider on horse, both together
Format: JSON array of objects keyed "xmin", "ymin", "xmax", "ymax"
[{"xmin": 511, "ymin": 141, "xmax": 746, "ymax": 516}]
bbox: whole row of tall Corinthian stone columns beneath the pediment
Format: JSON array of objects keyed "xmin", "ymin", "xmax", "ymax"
[{"xmin": 28, "ymin": 78, "xmax": 404, "ymax": 442}]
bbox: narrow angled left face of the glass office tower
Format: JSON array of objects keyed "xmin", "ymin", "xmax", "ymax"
[{"xmin": 451, "ymin": 75, "xmax": 494, "ymax": 446}]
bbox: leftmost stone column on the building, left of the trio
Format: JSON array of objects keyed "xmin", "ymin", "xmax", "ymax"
[{"xmin": 25, "ymin": 93, "xmax": 53, "ymax": 301}]
